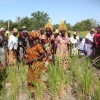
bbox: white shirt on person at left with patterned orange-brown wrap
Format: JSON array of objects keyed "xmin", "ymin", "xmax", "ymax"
[{"xmin": 8, "ymin": 35, "xmax": 18, "ymax": 50}]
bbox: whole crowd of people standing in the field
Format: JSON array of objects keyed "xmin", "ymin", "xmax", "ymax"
[{"xmin": 0, "ymin": 20, "xmax": 100, "ymax": 91}]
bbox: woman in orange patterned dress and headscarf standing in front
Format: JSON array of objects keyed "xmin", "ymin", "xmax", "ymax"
[{"xmin": 26, "ymin": 31, "xmax": 45, "ymax": 88}]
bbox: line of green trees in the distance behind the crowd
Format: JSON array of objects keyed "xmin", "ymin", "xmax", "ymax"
[{"xmin": 0, "ymin": 11, "xmax": 99, "ymax": 31}]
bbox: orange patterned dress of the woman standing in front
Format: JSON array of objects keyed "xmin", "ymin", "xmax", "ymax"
[{"xmin": 26, "ymin": 44, "xmax": 44, "ymax": 88}]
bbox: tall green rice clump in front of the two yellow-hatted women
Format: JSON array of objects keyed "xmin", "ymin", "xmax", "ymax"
[{"xmin": 47, "ymin": 65, "xmax": 59, "ymax": 100}]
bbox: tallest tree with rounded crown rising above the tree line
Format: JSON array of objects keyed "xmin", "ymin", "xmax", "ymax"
[{"xmin": 31, "ymin": 11, "xmax": 50, "ymax": 29}]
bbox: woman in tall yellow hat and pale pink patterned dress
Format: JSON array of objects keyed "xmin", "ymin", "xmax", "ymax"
[{"xmin": 55, "ymin": 20, "xmax": 69, "ymax": 69}]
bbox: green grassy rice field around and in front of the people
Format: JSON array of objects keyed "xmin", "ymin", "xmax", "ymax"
[{"xmin": 0, "ymin": 32, "xmax": 100, "ymax": 100}]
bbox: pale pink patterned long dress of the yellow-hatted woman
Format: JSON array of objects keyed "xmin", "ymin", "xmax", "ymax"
[{"xmin": 55, "ymin": 36, "xmax": 69, "ymax": 70}]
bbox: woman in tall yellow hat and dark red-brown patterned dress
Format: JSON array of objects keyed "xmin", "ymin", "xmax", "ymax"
[{"xmin": 43, "ymin": 20, "xmax": 55, "ymax": 68}]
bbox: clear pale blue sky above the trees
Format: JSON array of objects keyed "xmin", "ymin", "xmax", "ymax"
[{"xmin": 0, "ymin": 0, "xmax": 100, "ymax": 25}]
